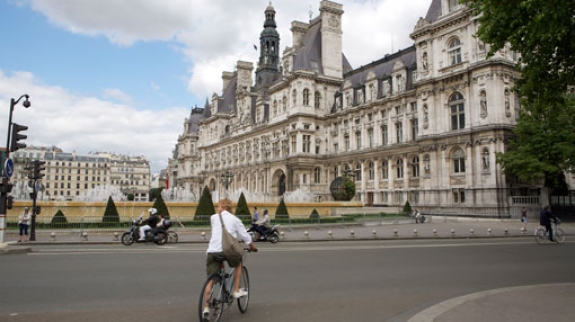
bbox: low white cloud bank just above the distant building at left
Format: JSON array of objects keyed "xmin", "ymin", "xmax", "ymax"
[{"xmin": 0, "ymin": 70, "xmax": 189, "ymax": 172}]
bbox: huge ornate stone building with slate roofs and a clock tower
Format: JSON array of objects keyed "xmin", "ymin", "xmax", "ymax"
[{"xmin": 169, "ymin": 0, "xmax": 538, "ymax": 215}]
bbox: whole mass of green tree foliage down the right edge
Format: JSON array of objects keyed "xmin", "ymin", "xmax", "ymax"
[{"xmin": 460, "ymin": 0, "xmax": 575, "ymax": 194}]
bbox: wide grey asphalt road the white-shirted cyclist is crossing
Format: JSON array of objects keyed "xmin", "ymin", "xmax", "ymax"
[{"xmin": 0, "ymin": 237, "xmax": 575, "ymax": 322}]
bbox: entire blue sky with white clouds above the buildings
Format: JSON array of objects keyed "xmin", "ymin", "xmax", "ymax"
[{"xmin": 0, "ymin": 0, "xmax": 432, "ymax": 173}]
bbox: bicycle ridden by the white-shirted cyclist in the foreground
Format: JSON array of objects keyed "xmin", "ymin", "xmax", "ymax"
[{"xmin": 198, "ymin": 253, "xmax": 250, "ymax": 322}]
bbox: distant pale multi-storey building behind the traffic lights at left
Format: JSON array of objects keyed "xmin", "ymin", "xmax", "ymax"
[{"xmin": 10, "ymin": 147, "xmax": 151, "ymax": 201}]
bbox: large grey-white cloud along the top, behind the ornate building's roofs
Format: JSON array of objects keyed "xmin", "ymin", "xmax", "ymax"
[{"xmin": 28, "ymin": 0, "xmax": 432, "ymax": 97}]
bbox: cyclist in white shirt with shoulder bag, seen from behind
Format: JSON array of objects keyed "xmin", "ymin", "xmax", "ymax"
[{"xmin": 202, "ymin": 199, "xmax": 258, "ymax": 320}]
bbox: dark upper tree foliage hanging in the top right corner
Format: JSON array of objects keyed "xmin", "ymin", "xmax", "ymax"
[{"xmin": 460, "ymin": 0, "xmax": 575, "ymax": 107}]
